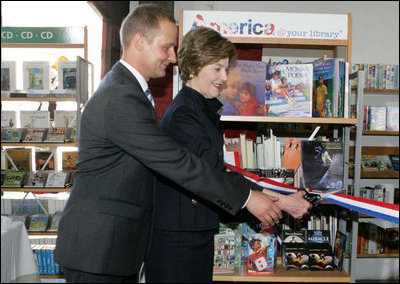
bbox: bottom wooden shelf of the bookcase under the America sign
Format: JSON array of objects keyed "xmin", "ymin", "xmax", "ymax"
[{"xmin": 213, "ymin": 260, "xmax": 350, "ymax": 283}]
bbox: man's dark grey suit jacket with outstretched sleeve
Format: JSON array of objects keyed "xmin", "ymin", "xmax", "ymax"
[{"xmin": 55, "ymin": 63, "xmax": 249, "ymax": 275}]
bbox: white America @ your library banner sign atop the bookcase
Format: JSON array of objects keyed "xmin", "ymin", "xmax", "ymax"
[{"xmin": 182, "ymin": 11, "xmax": 348, "ymax": 40}]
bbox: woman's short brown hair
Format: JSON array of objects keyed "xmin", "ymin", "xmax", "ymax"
[{"xmin": 178, "ymin": 28, "xmax": 236, "ymax": 81}]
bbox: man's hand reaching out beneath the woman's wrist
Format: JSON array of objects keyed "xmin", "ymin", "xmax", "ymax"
[{"xmin": 246, "ymin": 190, "xmax": 282, "ymax": 227}]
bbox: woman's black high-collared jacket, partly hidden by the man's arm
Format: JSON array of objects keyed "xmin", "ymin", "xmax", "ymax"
[{"xmin": 155, "ymin": 86, "xmax": 262, "ymax": 231}]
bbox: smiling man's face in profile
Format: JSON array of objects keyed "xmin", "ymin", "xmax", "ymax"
[{"xmin": 141, "ymin": 20, "xmax": 177, "ymax": 81}]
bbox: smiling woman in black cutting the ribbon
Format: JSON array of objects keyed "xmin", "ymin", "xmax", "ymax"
[{"xmin": 145, "ymin": 28, "xmax": 310, "ymax": 283}]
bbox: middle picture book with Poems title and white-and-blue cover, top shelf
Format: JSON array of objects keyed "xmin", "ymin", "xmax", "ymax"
[{"xmin": 265, "ymin": 64, "xmax": 313, "ymax": 117}]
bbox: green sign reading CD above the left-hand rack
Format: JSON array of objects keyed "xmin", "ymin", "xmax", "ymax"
[{"xmin": 1, "ymin": 27, "xmax": 84, "ymax": 44}]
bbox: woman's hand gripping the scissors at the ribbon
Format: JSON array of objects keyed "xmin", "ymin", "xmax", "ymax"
[{"xmin": 262, "ymin": 189, "xmax": 313, "ymax": 219}]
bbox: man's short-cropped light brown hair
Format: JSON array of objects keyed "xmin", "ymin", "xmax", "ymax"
[{"xmin": 120, "ymin": 4, "xmax": 176, "ymax": 49}]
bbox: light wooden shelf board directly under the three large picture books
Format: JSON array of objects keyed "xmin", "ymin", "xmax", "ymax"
[{"xmin": 221, "ymin": 115, "xmax": 357, "ymax": 125}]
